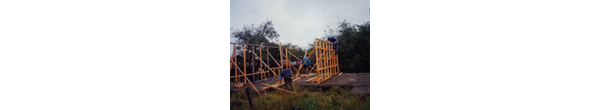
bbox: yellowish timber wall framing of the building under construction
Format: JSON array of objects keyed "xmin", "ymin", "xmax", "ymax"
[{"xmin": 229, "ymin": 38, "xmax": 340, "ymax": 87}]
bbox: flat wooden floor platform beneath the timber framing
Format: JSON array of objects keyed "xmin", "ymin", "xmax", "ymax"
[{"xmin": 229, "ymin": 73, "xmax": 371, "ymax": 94}]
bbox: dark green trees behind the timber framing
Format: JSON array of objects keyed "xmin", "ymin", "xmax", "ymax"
[{"xmin": 230, "ymin": 20, "xmax": 370, "ymax": 72}]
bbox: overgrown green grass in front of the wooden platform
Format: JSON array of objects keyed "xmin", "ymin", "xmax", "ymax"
[{"xmin": 230, "ymin": 86, "xmax": 370, "ymax": 110}]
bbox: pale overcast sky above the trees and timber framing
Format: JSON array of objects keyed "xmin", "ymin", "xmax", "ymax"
[{"xmin": 230, "ymin": 0, "xmax": 370, "ymax": 52}]
